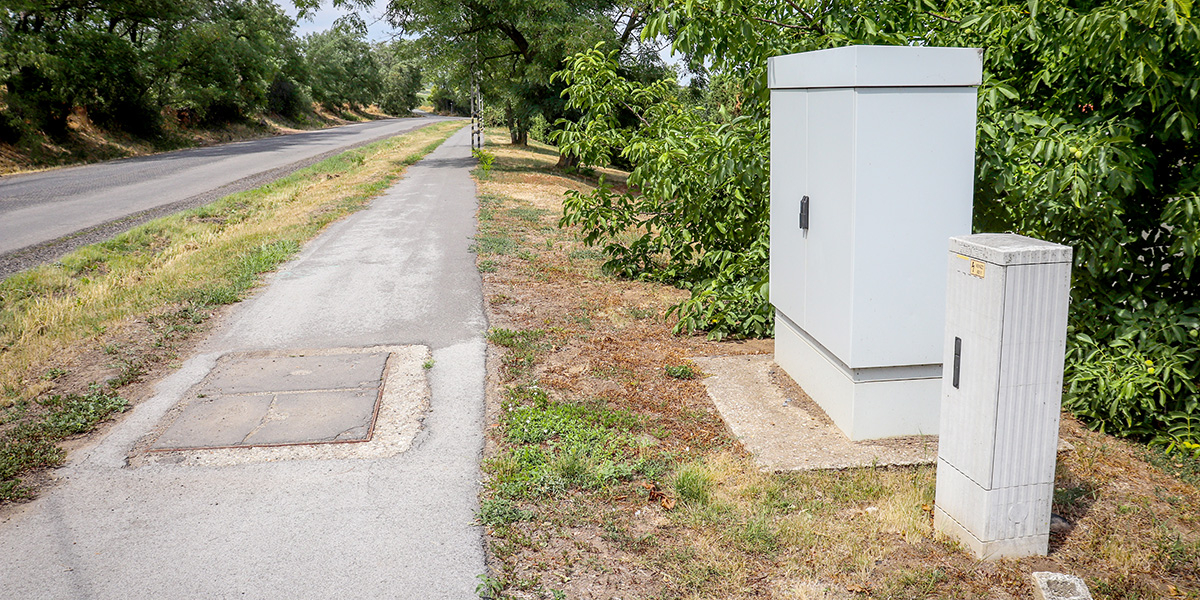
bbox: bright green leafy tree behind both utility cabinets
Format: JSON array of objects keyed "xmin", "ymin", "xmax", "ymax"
[{"xmin": 562, "ymin": 0, "xmax": 1200, "ymax": 448}]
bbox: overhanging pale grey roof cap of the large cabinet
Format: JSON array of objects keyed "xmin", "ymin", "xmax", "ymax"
[{"xmin": 767, "ymin": 46, "xmax": 983, "ymax": 90}]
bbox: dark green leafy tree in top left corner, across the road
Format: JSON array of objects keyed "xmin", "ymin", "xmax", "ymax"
[{"xmin": 0, "ymin": 0, "xmax": 309, "ymax": 138}]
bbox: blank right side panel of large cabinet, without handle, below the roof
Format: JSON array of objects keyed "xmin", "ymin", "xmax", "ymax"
[{"xmin": 847, "ymin": 88, "xmax": 976, "ymax": 367}]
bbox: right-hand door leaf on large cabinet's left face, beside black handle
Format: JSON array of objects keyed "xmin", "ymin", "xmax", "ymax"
[{"xmin": 799, "ymin": 89, "xmax": 854, "ymax": 364}]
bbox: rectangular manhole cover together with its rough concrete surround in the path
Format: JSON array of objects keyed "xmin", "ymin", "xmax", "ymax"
[{"xmin": 133, "ymin": 346, "xmax": 430, "ymax": 464}]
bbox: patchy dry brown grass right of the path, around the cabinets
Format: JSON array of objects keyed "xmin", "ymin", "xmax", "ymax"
[{"xmin": 479, "ymin": 134, "xmax": 1200, "ymax": 599}]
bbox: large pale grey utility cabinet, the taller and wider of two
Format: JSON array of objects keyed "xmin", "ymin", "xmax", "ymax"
[{"xmin": 768, "ymin": 46, "xmax": 982, "ymax": 439}]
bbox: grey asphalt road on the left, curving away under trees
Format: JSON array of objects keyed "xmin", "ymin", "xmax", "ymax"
[{"xmin": 0, "ymin": 116, "xmax": 458, "ymax": 280}]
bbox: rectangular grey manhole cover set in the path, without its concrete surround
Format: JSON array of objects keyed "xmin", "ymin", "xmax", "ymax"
[{"xmin": 150, "ymin": 352, "xmax": 391, "ymax": 451}]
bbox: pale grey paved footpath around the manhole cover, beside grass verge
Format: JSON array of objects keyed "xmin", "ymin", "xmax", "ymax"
[{"xmin": 0, "ymin": 124, "xmax": 486, "ymax": 599}]
